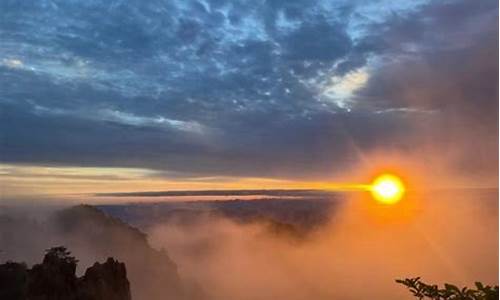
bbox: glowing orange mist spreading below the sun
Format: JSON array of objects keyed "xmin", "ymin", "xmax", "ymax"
[{"xmin": 149, "ymin": 190, "xmax": 498, "ymax": 300}]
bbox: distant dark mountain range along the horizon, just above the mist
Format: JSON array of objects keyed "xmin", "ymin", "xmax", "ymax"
[{"xmin": 97, "ymin": 197, "xmax": 341, "ymax": 237}]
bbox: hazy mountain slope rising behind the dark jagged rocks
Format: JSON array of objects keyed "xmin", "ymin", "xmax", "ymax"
[{"xmin": 0, "ymin": 205, "xmax": 202, "ymax": 300}]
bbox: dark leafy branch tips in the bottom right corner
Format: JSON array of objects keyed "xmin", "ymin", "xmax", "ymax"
[{"xmin": 396, "ymin": 277, "xmax": 498, "ymax": 300}]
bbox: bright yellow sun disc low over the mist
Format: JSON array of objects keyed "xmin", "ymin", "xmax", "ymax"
[{"xmin": 370, "ymin": 174, "xmax": 405, "ymax": 204}]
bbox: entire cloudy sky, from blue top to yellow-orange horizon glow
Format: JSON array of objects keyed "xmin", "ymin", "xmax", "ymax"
[{"xmin": 0, "ymin": 0, "xmax": 498, "ymax": 199}]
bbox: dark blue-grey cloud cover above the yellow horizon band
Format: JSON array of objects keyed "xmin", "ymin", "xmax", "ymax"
[{"xmin": 0, "ymin": 0, "xmax": 498, "ymax": 176}]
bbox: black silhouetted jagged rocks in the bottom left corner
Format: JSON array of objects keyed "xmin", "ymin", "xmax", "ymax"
[{"xmin": 0, "ymin": 247, "xmax": 131, "ymax": 300}]
